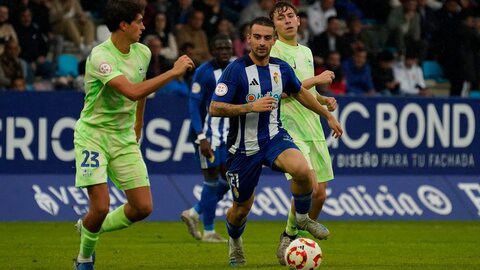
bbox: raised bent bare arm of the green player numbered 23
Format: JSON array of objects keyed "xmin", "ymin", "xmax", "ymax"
[{"xmin": 108, "ymin": 55, "xmax": 195, "ymax": 101}]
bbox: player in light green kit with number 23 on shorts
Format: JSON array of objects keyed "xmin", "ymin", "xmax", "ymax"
[{"xmin": 74, "ymin": 0, "xmax": 195, "ymax": 270}]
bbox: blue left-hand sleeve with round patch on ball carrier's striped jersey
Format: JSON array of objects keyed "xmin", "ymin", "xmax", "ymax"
[{"xmin": 212, "ymin": 62, "xmax": 240, "ymax": 103}]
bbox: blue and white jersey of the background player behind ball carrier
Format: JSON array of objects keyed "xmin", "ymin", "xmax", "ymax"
[{"xmin": 189, "ymin": 60, "xmax": 229, "ymax": 150}]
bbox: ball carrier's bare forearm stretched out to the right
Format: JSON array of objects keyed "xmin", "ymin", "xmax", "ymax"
[{"xmin": 293, "ymin": 87, "xmax": 343, "ymax": 138}]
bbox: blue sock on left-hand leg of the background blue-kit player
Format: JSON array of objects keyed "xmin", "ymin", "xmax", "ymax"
[{"xmin": 200, "ymin": 179, "xmax": 218, "ymax": 231}]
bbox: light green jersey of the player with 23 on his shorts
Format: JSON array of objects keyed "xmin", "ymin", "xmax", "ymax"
[{"xmin": 79, "ymin": 39, "xmax": 151, "ymax": 132}]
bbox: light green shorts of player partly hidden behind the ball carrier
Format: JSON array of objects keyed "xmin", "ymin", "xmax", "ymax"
[{"xmin": 285, "ymin": 140, "xmax": 333, "ymax": 183}]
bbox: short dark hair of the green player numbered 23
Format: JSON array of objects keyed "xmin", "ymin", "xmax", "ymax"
[{"xmin": 105, "ymin": 0, "xmax": 143, "ymax": 32}]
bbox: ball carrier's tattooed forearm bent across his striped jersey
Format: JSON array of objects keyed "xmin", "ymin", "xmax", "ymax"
[{"xmin": 210, "ymin": 96, "xmax": 277, "ymax": 117}]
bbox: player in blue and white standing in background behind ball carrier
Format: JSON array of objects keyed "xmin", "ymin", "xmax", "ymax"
[{"xmin": 181, "ymin": 34, "xmax": 233, "ymax": 243}]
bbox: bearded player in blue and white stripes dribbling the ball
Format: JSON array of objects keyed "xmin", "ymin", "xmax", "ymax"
[{"xmin": 210, "ymin": 17, "xmax": 343, "ymax": 266}]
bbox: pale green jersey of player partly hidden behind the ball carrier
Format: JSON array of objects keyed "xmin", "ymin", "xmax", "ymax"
[{"xmin": 270, "ymin": 40, "xmax": 325, "ymax": 141}]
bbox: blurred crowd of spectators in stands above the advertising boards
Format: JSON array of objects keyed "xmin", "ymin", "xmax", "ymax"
[{"xmin": 0, "ymin": 0, "xmax": 480, "ymax": 96}]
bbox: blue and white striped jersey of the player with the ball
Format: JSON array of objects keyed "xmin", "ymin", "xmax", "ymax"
[{"xmin": 212, "ymin": 55, "xmax": 301, "ymax": 155}]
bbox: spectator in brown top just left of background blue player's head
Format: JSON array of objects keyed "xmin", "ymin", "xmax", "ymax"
[{"xmin": 176, "ymin": 10, "xmax": 210, "ymax": 64}]
